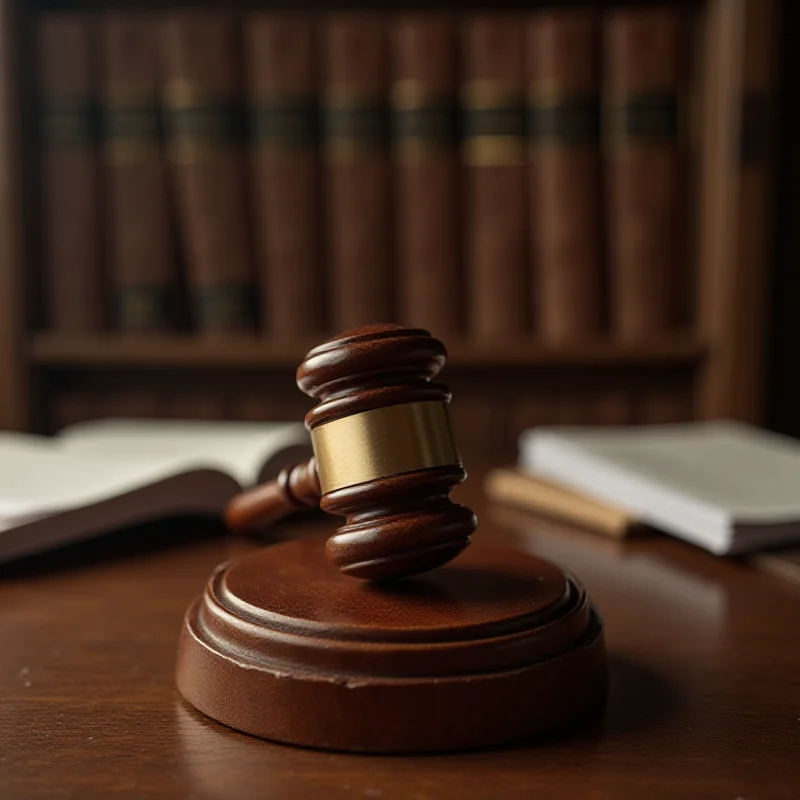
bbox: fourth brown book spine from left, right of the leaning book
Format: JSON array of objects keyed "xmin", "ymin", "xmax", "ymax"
[{"xmin": 245, "ymin": 13, "xmax": 325, "ymax": 338}]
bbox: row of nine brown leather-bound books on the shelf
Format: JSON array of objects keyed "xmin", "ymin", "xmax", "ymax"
[{"xmin": 37, "ymin": 6, "xmax": 686, "ymax": 342}]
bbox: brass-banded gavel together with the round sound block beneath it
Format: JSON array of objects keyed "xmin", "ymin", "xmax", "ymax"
[{"xmin": 176, "ymin": 325, "xmax": 606, "ymax": 753}]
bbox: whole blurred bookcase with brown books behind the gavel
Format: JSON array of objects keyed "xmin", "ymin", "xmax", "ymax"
[{"xmin": 0, "ymin": 0, "xmax": 800, "ymax": 458}]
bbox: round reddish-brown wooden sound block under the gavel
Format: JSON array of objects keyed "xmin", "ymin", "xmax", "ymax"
[{"xmin": 176, "ymin": 541, "xmax": 606, "ymax": 753}]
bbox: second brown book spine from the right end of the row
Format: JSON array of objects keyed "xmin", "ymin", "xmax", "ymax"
[{"xmin": 527, "ymin": 10, "xmax": 602, "ymax": 342}]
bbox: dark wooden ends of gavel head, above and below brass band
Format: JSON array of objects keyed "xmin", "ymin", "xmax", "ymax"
[{"xmin": 297, "ymin": 324, "xmax": 475, "ymax": 579}]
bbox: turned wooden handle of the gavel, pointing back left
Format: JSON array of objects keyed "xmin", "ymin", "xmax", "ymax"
[{"xmin": 225, "ymin": 458, "xmax": 321, "ymax": 533}]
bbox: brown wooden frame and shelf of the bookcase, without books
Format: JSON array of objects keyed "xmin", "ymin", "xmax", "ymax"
[{"xmin": 0, "ymin": 0, "xmax": 778, "ymax": 456}]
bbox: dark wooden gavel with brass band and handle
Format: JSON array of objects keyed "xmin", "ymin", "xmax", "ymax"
[{"xmin": 225, "ymin": 324, "xmax": 477, "ymax": 580}]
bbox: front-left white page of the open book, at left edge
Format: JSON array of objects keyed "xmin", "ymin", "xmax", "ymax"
[{"xmin": 0, "ymin": 437, "xmax": 222, "ymax": 530}]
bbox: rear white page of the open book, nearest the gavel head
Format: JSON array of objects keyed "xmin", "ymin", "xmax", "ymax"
[{"xmin": 58, "ymin": 419, "xmax": 309, "ymax": 487}]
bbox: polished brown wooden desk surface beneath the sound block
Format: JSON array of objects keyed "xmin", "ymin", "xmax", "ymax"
[{"xmin": 0, "ymin": 466, "xmax": 800, "ymax": 800}]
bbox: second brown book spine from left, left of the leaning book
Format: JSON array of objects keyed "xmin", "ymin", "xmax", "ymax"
[{"xmin": 101, "ymin": 13, "xmax": 177, "ymax": 332}]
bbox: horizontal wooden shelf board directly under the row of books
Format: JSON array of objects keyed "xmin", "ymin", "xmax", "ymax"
[{"xmin": 30, "ymin": 333, "xmax": 707, "ymax": 368}]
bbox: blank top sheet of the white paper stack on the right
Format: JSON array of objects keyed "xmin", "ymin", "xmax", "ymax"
[{"xmin": 523, "ymin": 422, "xmax": 800, "ymax": 524}]
